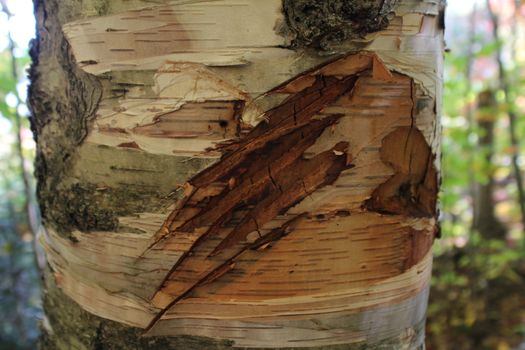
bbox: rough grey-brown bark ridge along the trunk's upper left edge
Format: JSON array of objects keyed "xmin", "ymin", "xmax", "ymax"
[{"xmin": 29, "ymin": 0, "xmax": 105, "ymax": 235}]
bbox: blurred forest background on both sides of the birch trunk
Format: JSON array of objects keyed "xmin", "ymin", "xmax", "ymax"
[{"xmin": 0, "ymin": 0, "xmax": 525, "ymax": 350}]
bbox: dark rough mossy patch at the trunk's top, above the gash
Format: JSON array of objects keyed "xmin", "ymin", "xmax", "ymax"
[{"xmin": 283, "ymin": 0, "xmax": 397, "ymax": 50}]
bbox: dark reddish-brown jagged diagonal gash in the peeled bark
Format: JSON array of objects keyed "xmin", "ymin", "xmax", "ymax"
[{"xmin": 145, "ymin": 75, "xmax": 362, "ymax": 318}]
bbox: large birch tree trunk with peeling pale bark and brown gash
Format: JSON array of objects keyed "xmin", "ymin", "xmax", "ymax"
[{"xmin": 30, "ymin": 0, "xmax": 443, "ymax": 349}]
